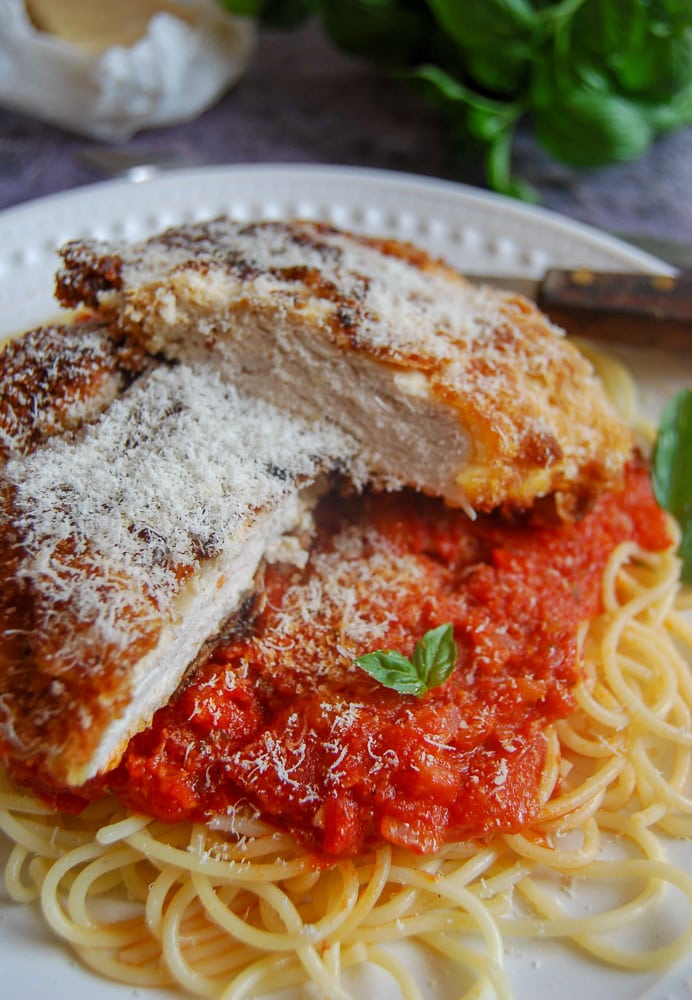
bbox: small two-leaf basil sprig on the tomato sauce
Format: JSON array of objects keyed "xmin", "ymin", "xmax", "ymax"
[{"xmin": 355, "ymin": 624, "xmax": 457, "ymax": 698}]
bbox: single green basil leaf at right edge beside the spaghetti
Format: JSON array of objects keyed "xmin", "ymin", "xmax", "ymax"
[{"xmin": 652, "ymin": 389, "xmax": 692, "ymax": 583}]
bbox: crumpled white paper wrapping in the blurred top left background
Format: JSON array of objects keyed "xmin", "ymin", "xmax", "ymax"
[{"xmin": 0, "ymin": 0, "xmax": 255, "ymax": 142}]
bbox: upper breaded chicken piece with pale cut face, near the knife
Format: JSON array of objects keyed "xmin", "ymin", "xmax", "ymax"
[{"xmin": 57, "ymin": 218, "xmax": 632, "ymax": 516}]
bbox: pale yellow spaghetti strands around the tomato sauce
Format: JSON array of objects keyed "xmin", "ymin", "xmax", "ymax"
[{"xmin": 0, "ymin": 480, "xmax": 692, "ymax": 1000}]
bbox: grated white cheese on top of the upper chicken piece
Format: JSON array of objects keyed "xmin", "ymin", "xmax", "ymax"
[{"xmin": 70, "ymin": 218, "xmax": 512, "ymax": 360}]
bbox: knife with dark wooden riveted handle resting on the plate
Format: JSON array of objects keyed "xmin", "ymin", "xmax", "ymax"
[{"xmin": 466, "ymin": 267, "xmax": 692, "ymax": 350}]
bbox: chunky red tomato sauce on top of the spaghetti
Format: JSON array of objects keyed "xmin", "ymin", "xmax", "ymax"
[{"xmin": 9, "ymin": 467, "xmax": 669, "ymax": 855}]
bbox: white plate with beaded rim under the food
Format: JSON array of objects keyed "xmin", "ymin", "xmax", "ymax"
[{"xmin": 0, "ymin": 166, "xmax": 692, "ymax": 1000}]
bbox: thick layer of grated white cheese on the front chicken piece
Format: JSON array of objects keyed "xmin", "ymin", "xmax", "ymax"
[{"xmin": 6, "ymin": 365, "xmax": 351, "ymax": 654}]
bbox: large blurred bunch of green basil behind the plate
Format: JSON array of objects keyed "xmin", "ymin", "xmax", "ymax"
[{"xmin": 218, "ymin": 0, "xmax": 692, "ymax": 198}]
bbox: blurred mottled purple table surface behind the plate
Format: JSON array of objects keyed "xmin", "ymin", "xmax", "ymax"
[{"xmin": 0, "ymin": 25, "xmax": 692, "ymax": 252}]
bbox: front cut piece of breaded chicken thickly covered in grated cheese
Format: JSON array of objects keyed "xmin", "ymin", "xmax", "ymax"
[{"xmin": 0, "ymin": 363, "xmax": 358, "ymax": 783}]
